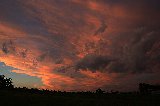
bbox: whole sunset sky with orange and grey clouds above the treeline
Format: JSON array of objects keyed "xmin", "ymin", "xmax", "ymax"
[{"xmin": 0, "ymin": 0, "xmax": 160, "ymax": 91}]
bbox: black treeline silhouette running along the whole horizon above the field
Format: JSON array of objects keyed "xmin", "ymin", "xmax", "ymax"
[{"xmin": 0, "ymin": 75, "xmax": 160, "ymax": 96}]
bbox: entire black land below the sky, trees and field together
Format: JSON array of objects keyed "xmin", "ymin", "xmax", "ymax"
[{"xmin": 0, "ymin": 75, "xmax": 160, "ymax": 106}]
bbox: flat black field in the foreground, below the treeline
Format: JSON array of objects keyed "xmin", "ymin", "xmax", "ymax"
[{"xmin": 0, "ymin": 90, "xmax": 160, "ymax": 106}]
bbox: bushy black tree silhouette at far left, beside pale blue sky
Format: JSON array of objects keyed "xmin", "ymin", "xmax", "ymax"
[{"xmin": 0, "ymin": 75, "xmax": 13, "ymax": 89}]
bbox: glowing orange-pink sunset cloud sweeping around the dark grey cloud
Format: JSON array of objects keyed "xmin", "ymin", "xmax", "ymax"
[{"xmin": 0, "ymin": 0, "xmax": 159, "ymax": 90}]
